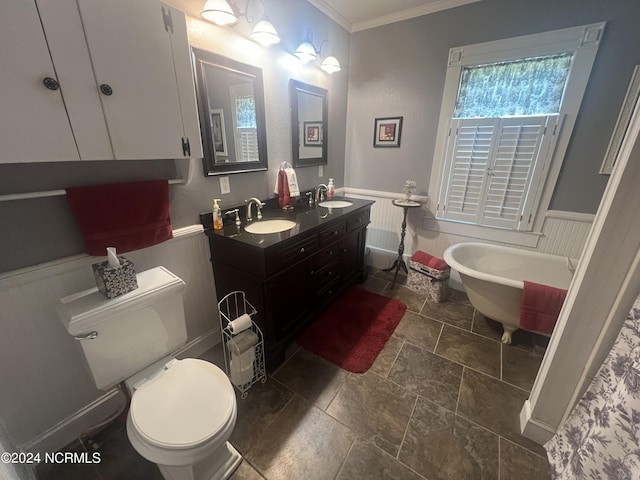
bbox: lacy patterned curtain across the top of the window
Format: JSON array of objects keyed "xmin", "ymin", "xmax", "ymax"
[{"xmin": 454, "ymin": 53, "xmax": 573, "ymax": 118}]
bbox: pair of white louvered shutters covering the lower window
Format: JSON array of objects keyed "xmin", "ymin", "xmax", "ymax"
[{"xmin": 438, "ymin": 115, "xmax": 558, "ymax": 230}]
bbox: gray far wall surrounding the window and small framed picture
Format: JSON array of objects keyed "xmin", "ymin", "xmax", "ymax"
[{"xmin": 345, "ymin": 0, "xmax": 640, "ymax": 213}]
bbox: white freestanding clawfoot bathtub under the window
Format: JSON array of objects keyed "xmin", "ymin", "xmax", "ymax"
[{"xmin": 444, "ymin": 243, "xmax": 575, "ymax": 343}]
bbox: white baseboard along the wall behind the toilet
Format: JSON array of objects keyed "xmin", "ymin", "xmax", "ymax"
[{"xmin": 21, "ymin": 327, "xmax": 220, "ymax": 455}]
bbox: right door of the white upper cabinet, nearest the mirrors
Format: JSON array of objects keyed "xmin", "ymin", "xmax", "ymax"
[{"xmin": 75, "ymin": 0, "xmax": 196, "ymax": 160}]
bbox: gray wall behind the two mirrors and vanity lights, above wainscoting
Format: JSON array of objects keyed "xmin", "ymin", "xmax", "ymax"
[{"xmin": 0, "ymin": 0, "xmax": 349, "ymax": 272}]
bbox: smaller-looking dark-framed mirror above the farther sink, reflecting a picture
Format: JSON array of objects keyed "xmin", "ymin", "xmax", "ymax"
[{"xmin": 290, "ymin": 80, "xmax": 328, "ymax": 167}]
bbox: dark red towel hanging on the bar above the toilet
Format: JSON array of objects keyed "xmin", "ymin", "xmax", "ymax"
[{"xmin": 66, "ymin": 180, "xmax": 173, "ymax": 256}]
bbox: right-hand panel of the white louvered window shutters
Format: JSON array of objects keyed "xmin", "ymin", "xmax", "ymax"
[{"xmin": 478, "ymin": 115, "xmax": 557, "ymax": 230}]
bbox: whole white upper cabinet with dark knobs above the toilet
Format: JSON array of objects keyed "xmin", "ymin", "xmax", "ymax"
[{"xmin": 0, "ymin": 0, "xmax": 202, "ymax": 162}]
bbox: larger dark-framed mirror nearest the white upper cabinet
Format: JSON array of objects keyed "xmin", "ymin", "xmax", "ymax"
[{"xmin": 191, "ymin": 48, "xmax": 268, "ymax": 176}]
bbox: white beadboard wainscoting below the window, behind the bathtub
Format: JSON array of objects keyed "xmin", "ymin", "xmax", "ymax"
[{"xmin": 344, "ymin": 188, "xmax": 595, "ymax": 274}]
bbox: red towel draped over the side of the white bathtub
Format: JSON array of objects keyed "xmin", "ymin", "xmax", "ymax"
[{"xmin": 520, "ymin": 280, "xmax": 567, "ymax": 335}]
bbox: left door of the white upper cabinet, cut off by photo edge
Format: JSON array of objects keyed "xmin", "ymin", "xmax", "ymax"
[{"xmin": 0, "ymin": 0, "xmax": 79, "ymax": 163}]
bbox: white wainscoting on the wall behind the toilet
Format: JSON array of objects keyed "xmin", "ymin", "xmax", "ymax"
[{"xmin": 0, "ymin": 225, "xmax": 220, "ymax": 452}]
